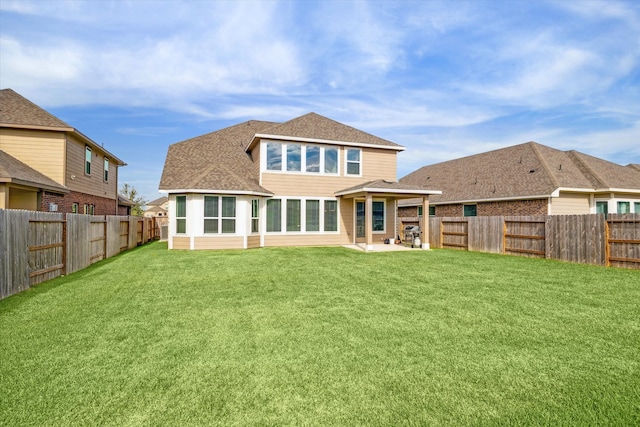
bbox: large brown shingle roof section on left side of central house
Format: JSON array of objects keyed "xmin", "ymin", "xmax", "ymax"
[{"xmin": 160, "ymin": 120, "xmax": 276, "ymax": 196}]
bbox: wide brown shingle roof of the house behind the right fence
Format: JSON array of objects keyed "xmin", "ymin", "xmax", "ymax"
[{"xmin": 400, "ymin": 142, "xmax": 640, "ymax": 205}]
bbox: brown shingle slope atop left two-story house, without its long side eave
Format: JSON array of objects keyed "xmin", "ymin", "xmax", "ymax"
[{"xmin": 0, "ymin": 89, "xmax": 73, "ymax": 131}]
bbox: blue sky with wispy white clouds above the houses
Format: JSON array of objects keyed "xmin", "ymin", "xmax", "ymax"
[{"xmin": 0, "ymin": 0, "xmax": 640, "ymax": 200}]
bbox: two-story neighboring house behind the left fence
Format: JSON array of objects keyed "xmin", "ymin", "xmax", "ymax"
[{"xmin": 0, "ymin": 89, "xmax": 125, "ymax": 215}]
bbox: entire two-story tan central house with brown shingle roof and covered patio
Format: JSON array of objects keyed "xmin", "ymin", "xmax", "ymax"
[{"xmin": 160, "ymin": 113, "xmax": 439, "ymax": 249}]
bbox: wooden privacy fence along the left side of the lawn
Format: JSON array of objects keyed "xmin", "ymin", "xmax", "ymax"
[{"xmin": 0, "ymin": 209, "xmax": 159, "ymax": 299}]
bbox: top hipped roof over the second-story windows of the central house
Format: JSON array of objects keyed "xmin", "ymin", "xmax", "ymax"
[{"xmin": 247, "ymin": 113, "xmax": 405, "ymax": 151}]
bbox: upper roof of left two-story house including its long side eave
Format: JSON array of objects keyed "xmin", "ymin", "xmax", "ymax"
[{"xmin": 0, "ymin": 89, "xmax": 126, "ymax": 166}]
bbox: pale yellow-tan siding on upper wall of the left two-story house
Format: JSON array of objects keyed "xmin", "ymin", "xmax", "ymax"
[{"xmin": 0, "ymin": 128, "xmax": 65, "ymax": 185}]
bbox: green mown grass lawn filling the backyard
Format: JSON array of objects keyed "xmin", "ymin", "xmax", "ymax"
[{"xmin": 0, "ymin": 243, "xmax": 640, "ymax": 426}]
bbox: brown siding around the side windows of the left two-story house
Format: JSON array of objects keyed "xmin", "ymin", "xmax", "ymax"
[{"xmin": 66, "ymin": 137, "xmax": 117, "ymax": 199}]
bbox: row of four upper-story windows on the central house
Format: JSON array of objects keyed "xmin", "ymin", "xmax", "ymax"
[{"xmin": 264, "ymin": 142, "xmax": 339, "ymax": 174}]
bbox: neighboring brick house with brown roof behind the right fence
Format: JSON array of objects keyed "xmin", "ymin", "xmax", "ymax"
[{"xmin": 398, "ymin": 142, "xmax": 640, "ymax": 222}]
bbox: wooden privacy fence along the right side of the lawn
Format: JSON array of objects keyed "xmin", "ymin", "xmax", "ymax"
[{"xmin": 429, "ymin": 214, "xmax": 640, "ymax": 269}]
